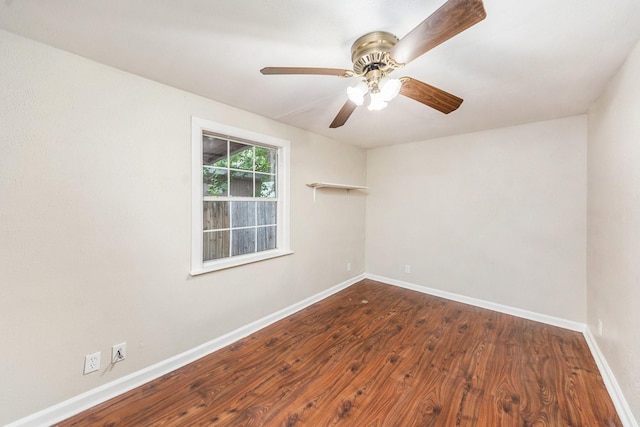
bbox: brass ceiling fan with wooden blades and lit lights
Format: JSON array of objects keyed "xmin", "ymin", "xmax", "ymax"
[{"xmin": 260, "ymin": 0, "xmax": 487, "ymax": 128}]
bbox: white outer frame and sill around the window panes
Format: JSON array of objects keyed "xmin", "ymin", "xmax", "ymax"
[{"xmin": 190, "ymin": 117, "xmax": 293, "ymax": 276}]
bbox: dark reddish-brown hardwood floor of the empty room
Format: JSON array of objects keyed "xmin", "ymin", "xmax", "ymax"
[{"xmin": 59, "ymin": 280, "xmax": 622, "ymax": 427}]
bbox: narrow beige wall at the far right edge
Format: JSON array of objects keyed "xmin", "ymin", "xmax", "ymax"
[{"xmin": 587, "ymin": 38, "xmax": 640, "ymax": 420}]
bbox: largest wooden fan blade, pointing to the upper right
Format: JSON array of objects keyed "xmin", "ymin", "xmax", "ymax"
[{"xmin": 389, "ymin": 0, "xmax": 487, "ymax": 64}]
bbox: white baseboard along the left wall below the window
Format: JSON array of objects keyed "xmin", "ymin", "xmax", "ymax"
[{"xmin": 6, "ymin": 274, "xmax": 365, "ymax": 427}]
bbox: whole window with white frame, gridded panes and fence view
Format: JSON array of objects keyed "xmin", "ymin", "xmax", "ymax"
[{"xmin": 191, "ymin": 118, "xmax": 291, "ymax": 275}]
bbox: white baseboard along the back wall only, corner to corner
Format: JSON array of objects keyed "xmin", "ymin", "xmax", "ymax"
[{"xmin": 365, "ymin": 274, "xmax": 586, "ymax": 332}]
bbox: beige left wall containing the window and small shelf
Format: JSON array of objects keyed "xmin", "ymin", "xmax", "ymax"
[{"xmin": 0, "ymin": 31, "xmax": 366, "ymax": 424}]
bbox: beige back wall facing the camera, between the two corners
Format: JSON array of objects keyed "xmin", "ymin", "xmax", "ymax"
[{"xmin": 366, "ymin": 116, "xmax": 587, "ymax": 322}]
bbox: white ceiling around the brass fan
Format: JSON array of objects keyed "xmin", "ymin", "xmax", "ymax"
[{"xmin": 0, "ymin": 0, "xmax": 640, "ymax": 147}]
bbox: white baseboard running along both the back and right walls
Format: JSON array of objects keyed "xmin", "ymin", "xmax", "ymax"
[{"xmin": 365, "ymin": 273, "xmax": 639, "ymax": 427}]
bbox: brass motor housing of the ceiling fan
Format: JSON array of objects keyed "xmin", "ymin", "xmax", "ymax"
[{"xmin": 351, "ymin": 31, "xmax": 399, "ymax": 76}]
